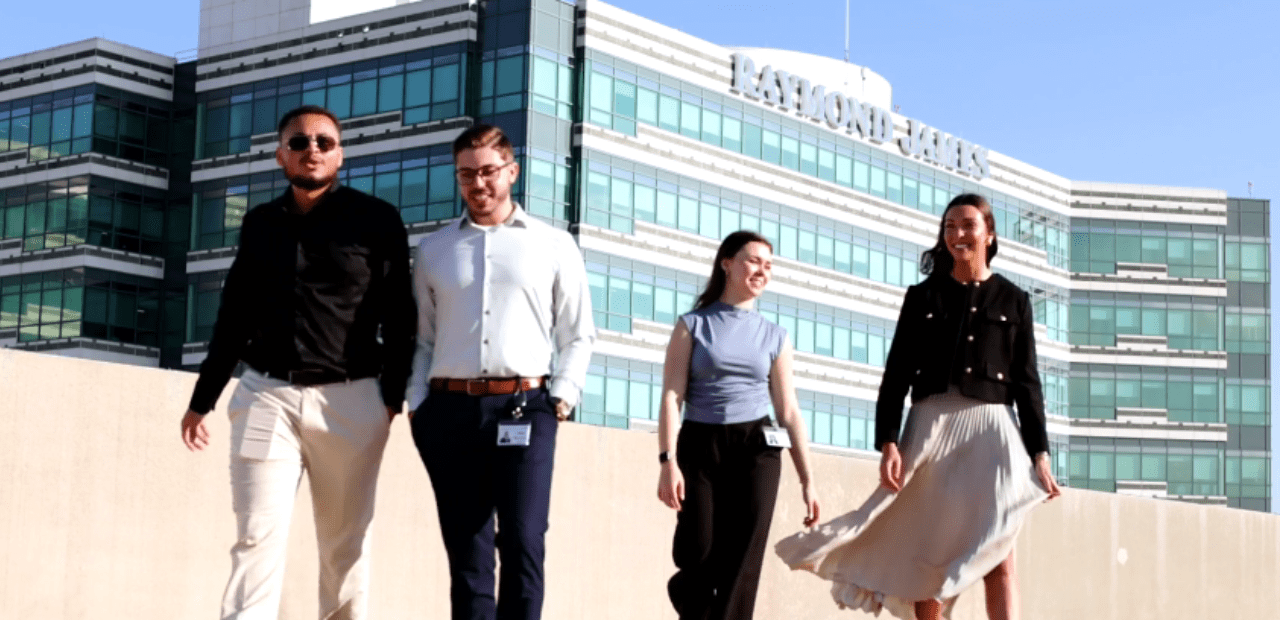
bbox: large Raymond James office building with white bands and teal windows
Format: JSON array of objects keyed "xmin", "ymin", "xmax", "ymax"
[{"xmin": 0, "ymin": 0, "xmax": 1271, "ymax": 510}]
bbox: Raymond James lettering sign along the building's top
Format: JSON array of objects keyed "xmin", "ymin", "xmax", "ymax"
[{"xmin": 732, "ymin": 54, "xmax": 991, "ymax": 179}]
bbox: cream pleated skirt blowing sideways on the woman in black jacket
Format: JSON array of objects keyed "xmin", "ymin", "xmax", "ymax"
[{"xmin": 776, "ymin": 391, "xmax": 1048, "ymax": 620}]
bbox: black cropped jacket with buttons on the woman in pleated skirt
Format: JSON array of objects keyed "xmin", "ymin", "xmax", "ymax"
[{"xmin": 876, "ymin": 274, "xmax": 1048, "ymax": 457}]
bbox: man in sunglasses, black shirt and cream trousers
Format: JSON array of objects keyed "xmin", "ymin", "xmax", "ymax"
[{"xmin": 182, "ymin": 105, "xmax": 417, "ymax": 620}]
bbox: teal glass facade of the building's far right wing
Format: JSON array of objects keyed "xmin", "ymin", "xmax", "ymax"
[{"xmin": 1066, "ymin": 199, "xmax": 1271, "ymax": 510}]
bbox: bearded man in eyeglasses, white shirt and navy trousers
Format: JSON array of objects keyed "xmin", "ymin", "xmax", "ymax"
[{"xmin": 408, "ymin": 124, "xmax": 595, "ymax": 620}]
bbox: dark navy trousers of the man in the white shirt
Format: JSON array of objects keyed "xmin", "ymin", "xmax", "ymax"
[{"xmin": 412, "ymin": 387, "xmax": 559, "ymax": 620}]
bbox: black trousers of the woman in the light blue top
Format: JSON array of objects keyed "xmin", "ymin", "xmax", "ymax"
[{"xmin": 667, "ymin": 418, "xmax": 782, "ymax": 620}]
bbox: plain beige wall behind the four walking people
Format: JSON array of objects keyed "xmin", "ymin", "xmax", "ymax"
[{"xmin": 0, "ymin": 350, "xmax": 1280, "ymax": 620}]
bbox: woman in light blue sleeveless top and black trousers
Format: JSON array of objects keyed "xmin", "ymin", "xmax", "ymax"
[{"xmin": 658, "ymin": 231, "xmax": 818, "ymax": 620}]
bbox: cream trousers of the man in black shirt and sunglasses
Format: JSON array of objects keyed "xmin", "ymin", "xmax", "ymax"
[{"xmin": 221, "ymin": 370, "xmax": 390, "ymax": 620}]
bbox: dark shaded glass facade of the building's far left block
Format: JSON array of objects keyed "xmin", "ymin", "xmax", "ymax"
[{"xmin": 0, "ymin": 56, "xmax": 195, "ymax": 365}]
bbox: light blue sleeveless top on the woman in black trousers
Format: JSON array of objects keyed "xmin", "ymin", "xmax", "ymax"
[{"xmin": 680, "ymin": 301, "xmax": 787, "ymax": 424}]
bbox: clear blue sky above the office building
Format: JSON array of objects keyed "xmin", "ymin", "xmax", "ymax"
[{"xmin": 0, "ymin": 0, "xmax": 1280, "ymax": 504}]
